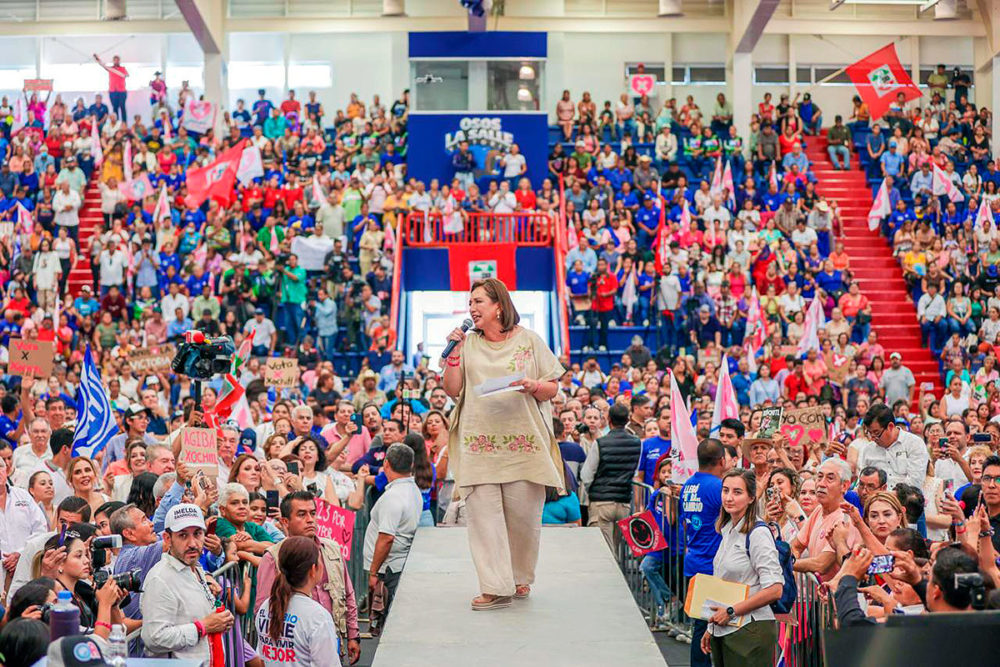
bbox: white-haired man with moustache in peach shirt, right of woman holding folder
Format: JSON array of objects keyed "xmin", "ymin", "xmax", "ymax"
[{"xmin": 791, "ymin": 457, "xmax": 861, "ymax": 581}]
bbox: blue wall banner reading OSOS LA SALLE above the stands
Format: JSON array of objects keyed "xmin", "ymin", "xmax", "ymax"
[{"xmin": 406, "ymin": 113, "xmax": 548, "ymax": 188}]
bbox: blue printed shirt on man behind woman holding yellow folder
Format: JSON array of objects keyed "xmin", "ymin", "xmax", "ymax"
[{"xmin": 681, "ymin": 472, "xmax": 722, "ymax": 577}]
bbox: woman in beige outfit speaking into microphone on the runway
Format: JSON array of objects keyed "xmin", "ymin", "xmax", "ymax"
[{"xmin": 443, "ymin": 278, "xmax": 564, "ymax": 611}]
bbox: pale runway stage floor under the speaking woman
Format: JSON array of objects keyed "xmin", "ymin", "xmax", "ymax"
[{"xmin": 372, "ymin": 527, "xmax": 666, "ymax": 667}]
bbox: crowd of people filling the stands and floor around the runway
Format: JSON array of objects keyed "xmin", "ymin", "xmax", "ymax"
[{"xmin": 0, "ymin": 53, "xmax": 1000, "ymax": 667}]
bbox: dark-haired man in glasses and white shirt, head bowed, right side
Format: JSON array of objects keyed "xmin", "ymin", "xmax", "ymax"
[{"xmin": 857, "ymin": 403, "xmax": 930, "ymax": 489}]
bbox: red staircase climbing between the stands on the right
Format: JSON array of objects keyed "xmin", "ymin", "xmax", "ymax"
[{"xmin": 806, "ymin": 131, "xmax": 944, "ymax": 396}]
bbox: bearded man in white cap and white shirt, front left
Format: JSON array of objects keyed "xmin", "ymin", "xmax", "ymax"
[{"xmin": 140, "ymin": 503, "xmax": 234, "ymax": 661}]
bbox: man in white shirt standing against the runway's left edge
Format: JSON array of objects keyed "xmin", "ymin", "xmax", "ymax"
[{"xmin": 364, "ymin": 443, "xmax": 424, "ymax": 615}]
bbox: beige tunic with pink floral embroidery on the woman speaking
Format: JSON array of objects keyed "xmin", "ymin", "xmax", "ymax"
[{"xmin": 448, "ymin": 328, "xmax": 564, "ymax": 498}]
